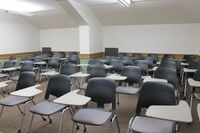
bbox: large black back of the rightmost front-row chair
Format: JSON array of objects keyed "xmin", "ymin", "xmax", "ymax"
[{"xmin": 136, "ymin": 82, "xmax": 176, "ymax": 115}]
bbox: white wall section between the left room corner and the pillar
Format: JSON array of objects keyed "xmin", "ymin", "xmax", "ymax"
[{"xmin": 40, "ymin": 27, "xmax": 79, "ymax": 51}]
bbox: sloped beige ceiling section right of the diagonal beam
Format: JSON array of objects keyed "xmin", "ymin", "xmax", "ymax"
[{"xmin": 92, "ymin": 0, "xmax": 200, "ymax": 25}]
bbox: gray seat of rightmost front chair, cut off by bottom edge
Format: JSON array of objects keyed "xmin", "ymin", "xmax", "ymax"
[{"xmin": 131, "ymin": 116, "xmax": 174, "ymax": 133}]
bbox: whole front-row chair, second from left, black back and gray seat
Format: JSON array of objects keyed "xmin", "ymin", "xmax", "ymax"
[{"xmin": 28, "ymin": 75, "xmax": 71, "ymax": 132}]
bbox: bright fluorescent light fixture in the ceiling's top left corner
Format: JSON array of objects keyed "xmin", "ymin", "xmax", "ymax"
[{"xmin": 0, "ymin": 0, "xmax": 45, "ymax": 16}]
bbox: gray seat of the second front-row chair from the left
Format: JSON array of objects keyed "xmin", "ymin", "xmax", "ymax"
[{"xmin": 30, "ymin": 101, "xmax": 65, "ymax": 115}]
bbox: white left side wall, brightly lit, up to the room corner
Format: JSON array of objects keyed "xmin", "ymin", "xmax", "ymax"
[{"xmin": 0, "ymin": 13, "xmax": 40, "ymax": 54}]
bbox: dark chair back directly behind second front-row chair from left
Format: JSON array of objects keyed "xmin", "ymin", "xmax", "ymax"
[{"xmin": 60, "ymin": 63, "xmax": 78, "ymax": 75}]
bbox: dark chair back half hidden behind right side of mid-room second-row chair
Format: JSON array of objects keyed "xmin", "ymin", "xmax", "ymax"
[{"xmin": 134, "ymin": 60, "xmax": 149, "ymax": 75}]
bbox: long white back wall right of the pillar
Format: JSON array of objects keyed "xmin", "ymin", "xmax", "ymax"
[{"xmin": 103, "ymin": 24, "xmax": 200, "ymax": 54}]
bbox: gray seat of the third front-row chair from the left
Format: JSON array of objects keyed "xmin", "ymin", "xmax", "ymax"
[{"xmin": 73, "ymin": 108, "xmax": 112, "ymax": 126}]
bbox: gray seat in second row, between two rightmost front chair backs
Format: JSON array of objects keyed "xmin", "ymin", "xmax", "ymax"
[{"xmin": 116, "ymin": 87, "xmax": 140, "ymax": 95}]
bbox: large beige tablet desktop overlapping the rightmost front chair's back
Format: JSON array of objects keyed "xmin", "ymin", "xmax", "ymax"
[{"xmin": 146, "ymin": 101, "xmax": 192, "ymax": 123}]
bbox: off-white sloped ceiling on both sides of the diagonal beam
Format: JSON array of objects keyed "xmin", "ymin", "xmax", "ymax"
[{"xmin": 21, "ymin": 0, "xmax": 200, "ymax": 29}]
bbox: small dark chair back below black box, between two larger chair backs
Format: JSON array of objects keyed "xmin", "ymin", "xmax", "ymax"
[{"xmin": 110, "ymin": 59, "xmax": 124, "ymax": 73}]
